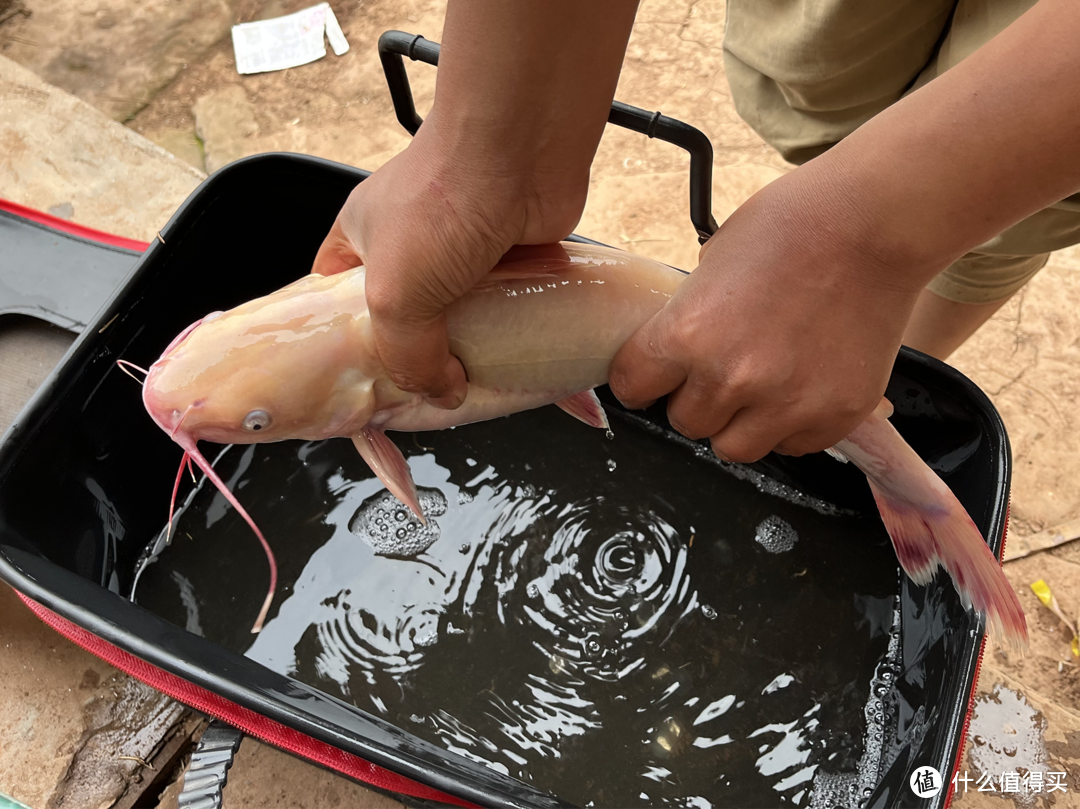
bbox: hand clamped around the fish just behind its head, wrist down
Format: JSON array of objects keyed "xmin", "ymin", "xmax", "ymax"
[{"xmin": 312, "ymin": 123, "xmax": 589, "ymax": 408}]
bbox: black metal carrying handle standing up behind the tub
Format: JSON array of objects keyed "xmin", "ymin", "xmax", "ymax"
[{"xmin": 379, "ymin": 31, "xmax": 718, "ymax": 244}]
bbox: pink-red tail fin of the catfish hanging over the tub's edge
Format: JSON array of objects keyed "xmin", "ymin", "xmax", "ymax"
[{"xmin": 868, "ymin": 477, "xmax": 1027, "ymax": 653}]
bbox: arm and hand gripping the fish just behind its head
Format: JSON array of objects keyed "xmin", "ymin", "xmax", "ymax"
[{"xmin": 313, "ymin": 0, "xmax": 636, "ymax": 407}]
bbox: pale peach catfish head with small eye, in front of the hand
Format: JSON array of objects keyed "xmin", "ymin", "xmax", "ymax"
[{"xmin": 143, "ymin": 271, "xmax": 380, "ymax": 448}]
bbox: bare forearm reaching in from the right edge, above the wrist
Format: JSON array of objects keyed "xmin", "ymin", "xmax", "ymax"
[{"xmin": 800, "ymin": 0, "xmax": 1080, "ymax": 286}]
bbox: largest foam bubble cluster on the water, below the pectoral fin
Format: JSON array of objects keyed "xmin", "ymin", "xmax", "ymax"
[{"xmin": 349, "ymin": 487, "xmax": 446, "ymax": 556}]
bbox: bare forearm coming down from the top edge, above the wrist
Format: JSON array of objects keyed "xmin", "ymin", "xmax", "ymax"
[{"xmin": 429, "ymin": 0, "xmax": 637, "ymax": 194}]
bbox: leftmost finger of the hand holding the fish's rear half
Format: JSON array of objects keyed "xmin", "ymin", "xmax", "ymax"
[{"xmin": 608, "ymin": 311, "xmax": 687, "ymax": 410}]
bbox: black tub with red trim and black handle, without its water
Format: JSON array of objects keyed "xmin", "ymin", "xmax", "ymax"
[{"xmin": 0, "ymin": 33, "xmax": 1010, "ymax": 809}]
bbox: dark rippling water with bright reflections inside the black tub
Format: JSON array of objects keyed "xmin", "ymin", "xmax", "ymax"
[{"xmin": 134, "ymin": 407, "xmax": 911, "ymax": 808}]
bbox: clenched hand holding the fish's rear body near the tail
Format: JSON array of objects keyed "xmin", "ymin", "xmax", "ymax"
[{"xmin": 610, "ymin": 170, "xmax": 926, "ymax": 462}]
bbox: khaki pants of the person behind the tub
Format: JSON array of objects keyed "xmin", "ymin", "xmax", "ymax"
[{"xmin": 724, "ymin": 0, "xmax": 1080, "ymax": 304}]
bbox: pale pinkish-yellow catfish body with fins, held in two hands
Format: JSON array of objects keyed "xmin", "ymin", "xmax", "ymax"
[{"xmin": 143, "ymin": 236, "xmax": 1027, "ymax": 650}]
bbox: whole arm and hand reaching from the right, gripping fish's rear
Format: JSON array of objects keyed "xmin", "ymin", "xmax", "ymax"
[{"xmin": 611, "ymin": 0, "xmax": 1080, "ymax": 461}]
